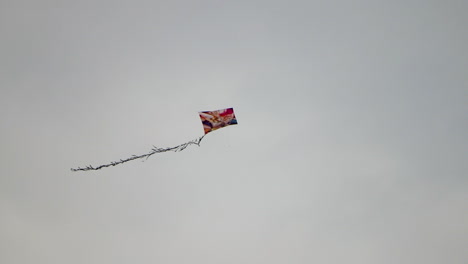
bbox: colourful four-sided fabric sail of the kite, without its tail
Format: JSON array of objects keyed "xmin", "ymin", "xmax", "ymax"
[{"xmin": 199, "ymin": 108, "xmax": 237, "ymax": 135}]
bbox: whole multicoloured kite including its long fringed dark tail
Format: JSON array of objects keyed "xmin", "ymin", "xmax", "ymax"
[{"xmin": 71, "ymin": 108, "xmax": 237, "ymax": 171}]
